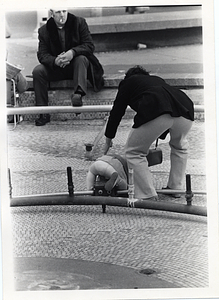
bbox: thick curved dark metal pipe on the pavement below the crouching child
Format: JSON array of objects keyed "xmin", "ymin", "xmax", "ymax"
[{"xmin": 10, "ymin": 194, "xmax": 207, "ymax": 216}]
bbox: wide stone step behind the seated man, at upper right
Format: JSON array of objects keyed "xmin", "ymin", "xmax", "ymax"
[{"xmin": 40, "ymin": 7, "xmax": 202, "ymax": 52}]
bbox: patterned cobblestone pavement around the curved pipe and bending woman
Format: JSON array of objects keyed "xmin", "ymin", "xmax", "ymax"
[{"xmin": 8, "ymin": 120, "xmax": 208, "ymax": 288}]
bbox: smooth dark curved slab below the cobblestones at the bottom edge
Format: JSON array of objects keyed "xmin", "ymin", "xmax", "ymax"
[{"xmin": 14, "ymin": 257, "xmax": 179, "ymax": 291}]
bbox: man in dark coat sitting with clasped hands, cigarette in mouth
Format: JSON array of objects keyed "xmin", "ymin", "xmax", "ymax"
[{"xmin": 33, "ymin": 9, "xmax": 103, "ymax": 126}]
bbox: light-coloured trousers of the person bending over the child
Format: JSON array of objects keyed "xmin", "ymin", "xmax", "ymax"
[{"xmin": 125, "ymin": 114, "xmax": 192, "ymax": 199}]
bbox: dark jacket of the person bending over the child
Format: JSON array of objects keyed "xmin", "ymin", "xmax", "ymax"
[{"xmin": 105, "ymin": 74, "xmax": 194, "ymax": 138}]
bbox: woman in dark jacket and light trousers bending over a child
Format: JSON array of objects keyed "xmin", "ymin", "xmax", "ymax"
[{"xmin": 104, "ymin": 66, "xmax": 194, "ymax": 200}]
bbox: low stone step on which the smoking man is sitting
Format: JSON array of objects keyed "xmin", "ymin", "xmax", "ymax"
[{"xmin": 19, "ymin": 74, "xmax": 204, "ymax": 121}]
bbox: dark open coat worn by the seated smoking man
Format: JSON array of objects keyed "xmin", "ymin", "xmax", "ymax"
[{"xmin": 37, "ymin": 13, "xmax": 103, "ymax": 91}]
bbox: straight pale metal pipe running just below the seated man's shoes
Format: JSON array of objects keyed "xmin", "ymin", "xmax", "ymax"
[{"xmin": 7, "ymin": 105, "xmax": 204, "ymax": 115}]
